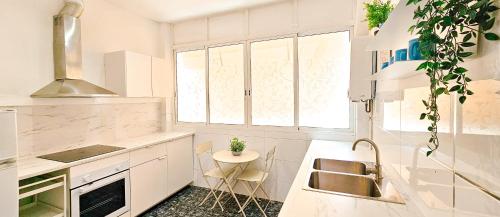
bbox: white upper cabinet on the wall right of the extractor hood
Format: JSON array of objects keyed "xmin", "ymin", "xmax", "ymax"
[{"xmin": 104, "ymin": 51, "xmax": 167, "ymax": 97}]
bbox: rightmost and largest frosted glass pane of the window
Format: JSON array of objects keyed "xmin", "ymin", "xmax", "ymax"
[{"xmin": 298, "ymin": 32, "xmax": 350, "ymax": 128}]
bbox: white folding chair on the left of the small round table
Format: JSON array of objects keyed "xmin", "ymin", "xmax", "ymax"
[{"xmin": 196, "ymin": 142, "xmax": 235, "ymax": 211}]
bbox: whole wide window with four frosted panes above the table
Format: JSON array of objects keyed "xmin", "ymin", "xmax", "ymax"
[{"xmin": 176, "ymin": 31, "xmax": 353, "ymax": 129}]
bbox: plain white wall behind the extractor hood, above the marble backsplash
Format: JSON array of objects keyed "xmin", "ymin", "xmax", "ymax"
[{"xmin": 0, "ymin": 0, "xmax": 164, "ymax": 97}]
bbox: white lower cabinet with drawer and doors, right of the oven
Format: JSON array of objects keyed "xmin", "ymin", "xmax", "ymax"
[{"xmin": 130, "ymin": 136, "xmax": 193, "ymax": 216}]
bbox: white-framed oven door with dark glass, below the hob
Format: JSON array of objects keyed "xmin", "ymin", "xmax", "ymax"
[{"xmin": 71, "ymin": 170, "xmax": 130, "ymax": 217}]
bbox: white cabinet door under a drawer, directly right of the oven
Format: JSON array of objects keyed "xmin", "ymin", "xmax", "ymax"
[{"xmin": 130, "ymin": 156, "xmax": 168, "ymax": 216}]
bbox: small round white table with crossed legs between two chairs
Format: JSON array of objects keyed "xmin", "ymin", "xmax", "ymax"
[{"xmin": 212, "ymin": 150, "xmax": 259, "ymax": 216}]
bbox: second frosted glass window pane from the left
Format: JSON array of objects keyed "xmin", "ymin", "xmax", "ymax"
[{"xmin": 208, "ymin": 44, "xmax": 245, "ymax": 124}]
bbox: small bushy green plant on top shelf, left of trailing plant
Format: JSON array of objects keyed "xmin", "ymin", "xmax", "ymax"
[{"xmin": 365, "ymin": 0, "xmax": 394, "ymax": 30}]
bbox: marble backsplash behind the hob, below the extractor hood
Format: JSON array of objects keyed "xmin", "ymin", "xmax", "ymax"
[{"xmin": 0, "ymin": 101, "xmax": 165, "ymax": 157}]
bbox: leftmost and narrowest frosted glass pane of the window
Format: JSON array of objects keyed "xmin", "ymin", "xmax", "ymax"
[{"xmin": 176, "ymin": 50, "xmax": 207, "ymax": 122}]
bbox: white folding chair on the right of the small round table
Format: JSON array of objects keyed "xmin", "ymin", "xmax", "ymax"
[{"xmin": 236, "ymin": 146, "xmax": 276, "ymax": 217}]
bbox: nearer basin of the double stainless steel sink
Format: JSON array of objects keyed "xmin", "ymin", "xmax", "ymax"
[{"xmin": 308, "ymin": 171, "xmax": 382, "ymax": 198}]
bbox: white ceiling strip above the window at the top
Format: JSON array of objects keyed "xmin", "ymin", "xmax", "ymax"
[{"xmin": 106, "ymin": 0, "xmax": 283, "ymax": 23}]
